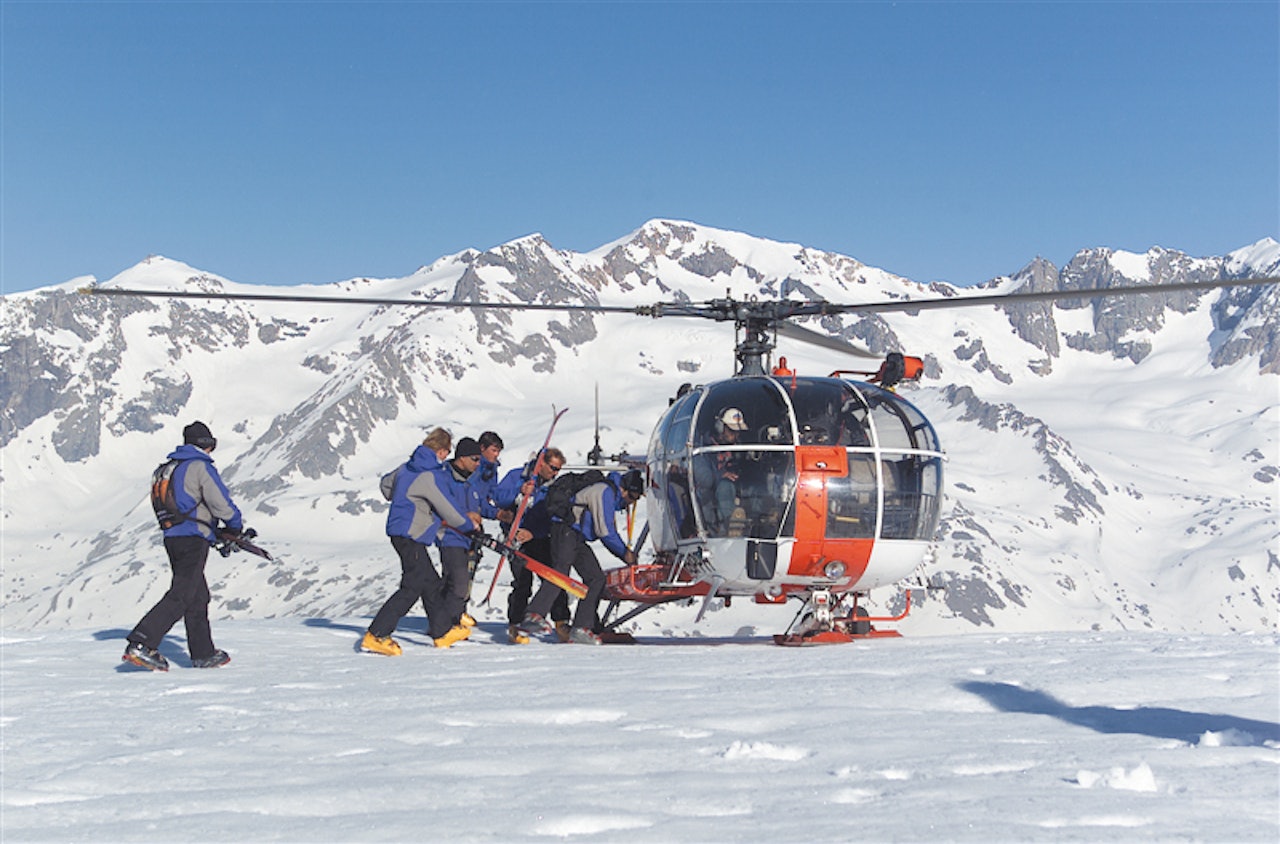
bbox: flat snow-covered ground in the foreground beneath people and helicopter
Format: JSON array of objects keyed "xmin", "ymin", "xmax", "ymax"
[{"xmin": 0, "ymin": 624, "xmax": 1280, "ymax": 843}]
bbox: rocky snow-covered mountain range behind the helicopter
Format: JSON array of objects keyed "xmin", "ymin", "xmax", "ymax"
[{"xmin": 0, "ymin": 220, "xmax": 1280, "ymax": 635}]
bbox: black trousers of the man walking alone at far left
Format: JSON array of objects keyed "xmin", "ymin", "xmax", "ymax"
[{"xmin": 128, "ymin": 537, "xmax": 216, "ymax": 660}]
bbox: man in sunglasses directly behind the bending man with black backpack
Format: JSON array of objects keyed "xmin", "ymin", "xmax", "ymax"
[{"xmin": 494, "ymin": 447, "xmax": 570, "ymax": 644}]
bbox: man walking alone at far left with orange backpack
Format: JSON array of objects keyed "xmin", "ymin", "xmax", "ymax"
[{"xmin": 122, "ymin": 421, "xmax": 244, "ymax": 671}]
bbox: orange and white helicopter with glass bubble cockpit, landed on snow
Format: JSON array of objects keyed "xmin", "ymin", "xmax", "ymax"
[{"xmin": 81, "ymin": 278, "xmax": 1280, "ymax": 645}]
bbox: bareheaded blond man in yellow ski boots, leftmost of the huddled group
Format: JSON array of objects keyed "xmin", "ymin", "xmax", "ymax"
[{"xmin": 360, "ymin": 428, "xmax": 479, "ymax": 657}]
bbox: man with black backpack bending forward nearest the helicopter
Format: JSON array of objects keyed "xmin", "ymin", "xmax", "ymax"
[{"xmin": 520, "ymin": 469, "xmax": 644, "ymax": 644}]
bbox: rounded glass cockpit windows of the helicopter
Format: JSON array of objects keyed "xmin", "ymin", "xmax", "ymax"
[{"xmin": 649, "ymin": 377, "xmax": 942, "ymax": 548}]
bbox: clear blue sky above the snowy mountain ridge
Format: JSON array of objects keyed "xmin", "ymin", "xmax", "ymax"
[{"xmin": 0, "ymin": 0, "xmax": 1280, "ymax": 292}]
